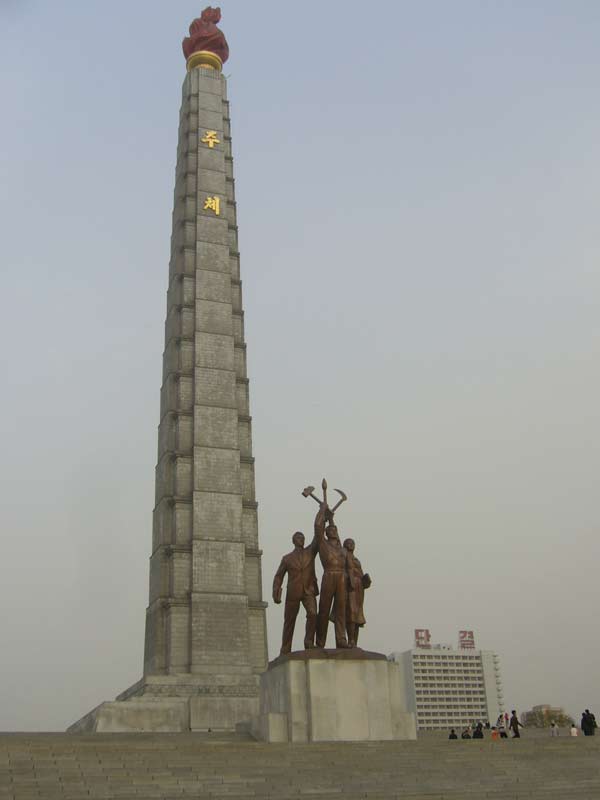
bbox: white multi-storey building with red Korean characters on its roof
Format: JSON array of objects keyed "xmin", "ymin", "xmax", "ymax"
[{"xmin": 389, "ymin": 632, "xmax": 505, "ymax": 730}]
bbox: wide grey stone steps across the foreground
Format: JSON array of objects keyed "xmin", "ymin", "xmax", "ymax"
[{"xmin": 0, "ymin": 734, "xmax": 600, "ymax": 800}]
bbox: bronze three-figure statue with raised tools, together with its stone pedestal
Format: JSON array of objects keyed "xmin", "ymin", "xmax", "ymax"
[{"xmin": 250, "ymin": 479, "xmax": 417, "ymax": 742}]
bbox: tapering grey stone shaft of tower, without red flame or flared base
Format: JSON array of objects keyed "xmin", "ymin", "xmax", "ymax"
[{"xmin": 145, "ymin": 67, "xmax": 267, "ymax": 700}]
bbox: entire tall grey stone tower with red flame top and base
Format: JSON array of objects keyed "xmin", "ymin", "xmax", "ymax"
[{"xmin": 69, "ymin": 8, "xmax": 267, "ymax": 731}]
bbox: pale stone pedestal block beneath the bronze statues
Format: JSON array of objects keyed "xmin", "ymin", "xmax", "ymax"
[{"xmin": 250, "ymin": 648, "xmax": 417, "ymax": 742}]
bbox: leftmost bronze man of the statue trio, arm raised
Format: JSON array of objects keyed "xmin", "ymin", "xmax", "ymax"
[{"xmin": 273, "ymin": 508, "xmax": 325, "ymax": 655}]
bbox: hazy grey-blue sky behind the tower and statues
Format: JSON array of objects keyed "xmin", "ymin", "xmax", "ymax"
[{"xmin": 0, "ymin": 0, "xmax": 600, "ymax": 730}]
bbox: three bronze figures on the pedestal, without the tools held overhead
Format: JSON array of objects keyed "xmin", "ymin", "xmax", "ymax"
[{"xmin": 273, "ymin": 503, "xmax": 371, "ymax": 655}]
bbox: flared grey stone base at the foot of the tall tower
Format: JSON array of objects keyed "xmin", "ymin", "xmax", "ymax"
[{"xmin": 67, "ymin": 674, "xmax": 259, "ymax": 733}]
